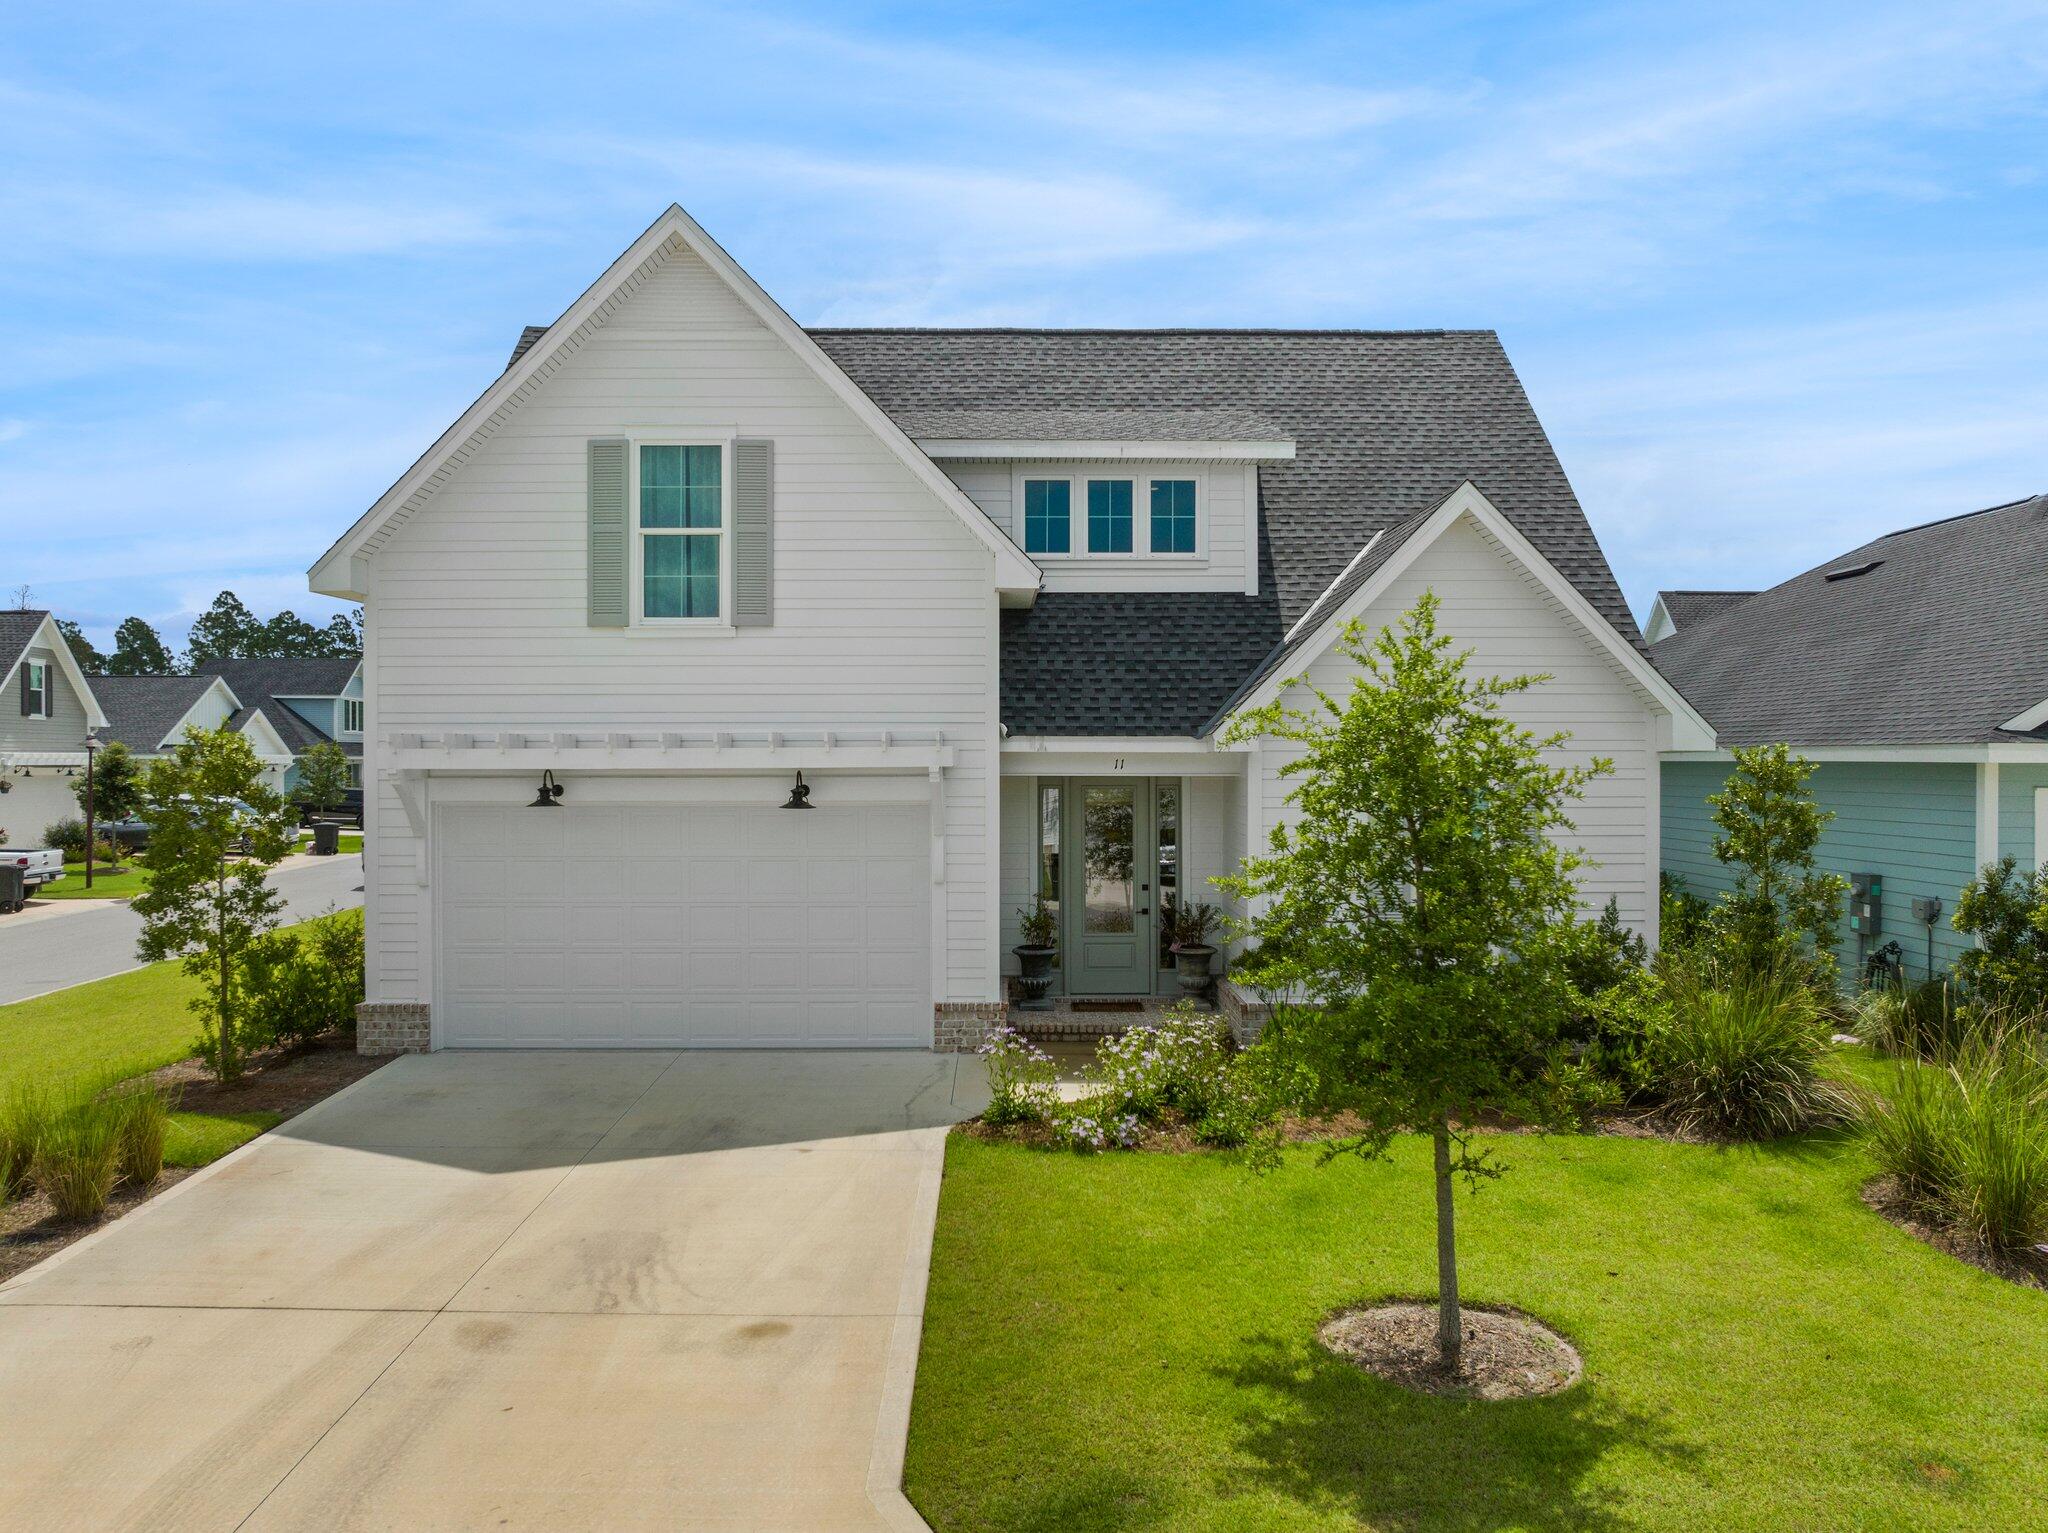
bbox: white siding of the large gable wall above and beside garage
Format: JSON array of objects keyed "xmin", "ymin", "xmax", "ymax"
[{"xmin": 365, "ymin": 246, "xmax": 997, "ymax": 1001}]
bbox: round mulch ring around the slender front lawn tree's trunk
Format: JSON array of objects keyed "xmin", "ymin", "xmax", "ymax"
[{"xmin": 1317, "ymin": 1300, "xmax": 1585, "ymax": 1400}]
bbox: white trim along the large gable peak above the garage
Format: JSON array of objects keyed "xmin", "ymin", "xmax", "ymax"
[{"xmin": 307, "ymin": 203, "xmax": 1042, "ymax": 602}]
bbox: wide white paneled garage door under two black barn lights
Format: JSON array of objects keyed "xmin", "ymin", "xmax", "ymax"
[{"xmin": 434, "ymin": 804, "xmax": 932, "ymax": 1048}]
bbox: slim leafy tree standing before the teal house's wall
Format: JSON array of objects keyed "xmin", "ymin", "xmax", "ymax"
[{"xmin": 1706, "ymin": 745, "xmax": 1849, "ymax": 982}]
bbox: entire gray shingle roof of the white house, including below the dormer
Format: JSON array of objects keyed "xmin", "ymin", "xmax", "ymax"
[{"xmin": 512, "ymin": 325, "xmax": 1642, "ymax": 735}]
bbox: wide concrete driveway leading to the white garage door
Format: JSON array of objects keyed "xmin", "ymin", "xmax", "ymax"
[{"xmin": 0, "ymin": 1052, "xmax": 985, "ymax": 1529}]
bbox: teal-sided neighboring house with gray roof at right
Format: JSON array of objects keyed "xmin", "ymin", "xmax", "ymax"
[{"xmin": 1645, "ymin": 495, "xmax": 2048, "ymax": 978}]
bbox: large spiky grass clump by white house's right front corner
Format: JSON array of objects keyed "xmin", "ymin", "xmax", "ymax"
[{"xmin": 1657, "ymin": 964, "xmax": 1849, "ymax": 1140}]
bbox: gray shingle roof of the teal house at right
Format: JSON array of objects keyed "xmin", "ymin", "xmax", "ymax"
[{"xmin": 1649, "ymin": 495, "xmax": 2048, "ymax": 745}]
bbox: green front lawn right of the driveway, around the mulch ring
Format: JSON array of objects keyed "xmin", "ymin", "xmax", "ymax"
[{"xmin": 905, "ymin": 1097, "xmax": 2048, "ymax": 1533}]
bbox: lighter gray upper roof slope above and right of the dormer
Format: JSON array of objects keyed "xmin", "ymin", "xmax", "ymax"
[{"xmin": 811, "ymin": 330, "xmax": 1636, "ymax": 650}]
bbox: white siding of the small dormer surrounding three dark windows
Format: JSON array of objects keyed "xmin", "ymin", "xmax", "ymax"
[{"xmin": 940, "ymin": 461, "xmax": 1257, "ymax": 592}]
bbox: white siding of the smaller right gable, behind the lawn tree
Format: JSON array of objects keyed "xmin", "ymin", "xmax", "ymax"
[{"xmin": 1253, "ymin": 522, "xmax": 1657, "ymax": 931}]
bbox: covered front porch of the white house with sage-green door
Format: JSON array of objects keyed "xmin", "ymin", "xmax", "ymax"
[{"xmin": 999, "ymin": 737, "xmax": 1247, "ymax": 1011}]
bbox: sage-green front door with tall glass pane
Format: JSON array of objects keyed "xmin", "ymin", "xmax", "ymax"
[{"xmin": 1063, "ymin": 778, "xmax": 1159, "ymax": 995}]
